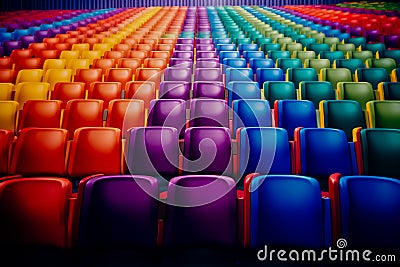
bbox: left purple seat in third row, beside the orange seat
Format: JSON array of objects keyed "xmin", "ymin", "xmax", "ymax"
[{"xmin": 147, "ymin": 99, "xmax": 186, "ymax": 139}]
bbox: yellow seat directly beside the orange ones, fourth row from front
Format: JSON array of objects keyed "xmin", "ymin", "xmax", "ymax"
[{"xmin": 14, "ymin": 82, "xmax": 50, "ymax": 110}]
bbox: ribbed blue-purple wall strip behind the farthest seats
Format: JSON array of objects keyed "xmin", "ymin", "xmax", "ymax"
[{"xmin": 0, "ymin": 0, "xmax": 343, "ymax": 11}]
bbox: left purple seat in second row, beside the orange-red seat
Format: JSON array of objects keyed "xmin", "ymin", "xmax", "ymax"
[{"xmin": 125, "ymin": 126, "xmax": 179, "ymax": 186}]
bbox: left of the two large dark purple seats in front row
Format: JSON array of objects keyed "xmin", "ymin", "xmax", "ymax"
[{"xmin": 78, "ymin": 175, "xmax": 158, "ymax": 248}]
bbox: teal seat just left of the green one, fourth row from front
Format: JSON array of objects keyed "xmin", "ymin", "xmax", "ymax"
[{"xmin": 299, "ymin": 81, "xmax": 336, "ymax": 109}]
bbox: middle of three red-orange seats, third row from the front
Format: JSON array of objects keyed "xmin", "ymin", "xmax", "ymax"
[{"xmin": 61, "ymin": 99, "xmax": 103, "ymax": 139}]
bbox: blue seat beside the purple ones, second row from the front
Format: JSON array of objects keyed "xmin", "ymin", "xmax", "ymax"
[{"xmin": 237, "ymin": 127, "xmax": 292, "ymax": 177}]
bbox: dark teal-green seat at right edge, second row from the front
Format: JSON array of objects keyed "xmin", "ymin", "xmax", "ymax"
[{"xmin": 356, "ymin": 128, "xmax": 400, "ymax": 178}]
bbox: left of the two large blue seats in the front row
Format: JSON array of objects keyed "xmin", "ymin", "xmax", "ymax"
[{"xmin": 244, "ymin": 175, "xmax": 332, "ymax": 249}]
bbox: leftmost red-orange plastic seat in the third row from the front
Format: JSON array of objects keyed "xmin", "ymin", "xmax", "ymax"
[{"xmin": 18, "ymin": 100, "xmax": 61, "ymax": 131}]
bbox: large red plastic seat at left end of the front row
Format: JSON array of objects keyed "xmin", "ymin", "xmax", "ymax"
[{"xmin": 0, "ymin": 177, "xmax": 72, "ymax": 248}]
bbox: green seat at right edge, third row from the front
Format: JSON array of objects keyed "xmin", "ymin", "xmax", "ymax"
[{"xmin": 367, "ymin": 100, "xmax": 400, "ymax": 129}]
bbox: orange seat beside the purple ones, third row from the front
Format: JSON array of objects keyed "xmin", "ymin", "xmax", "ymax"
[{"xmin": 106, "ymin": 99, "xmax": 145, "ymax": 134}]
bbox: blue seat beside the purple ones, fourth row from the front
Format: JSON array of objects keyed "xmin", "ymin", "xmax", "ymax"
[{"xmin": 227, "ymin": 81, "xmax": 261, "ymax": 107}]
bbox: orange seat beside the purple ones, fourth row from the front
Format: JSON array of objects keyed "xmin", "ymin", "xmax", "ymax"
[{"xmin": 125, "ymin": 81, "xmax": 156, "ymax": 109}]
